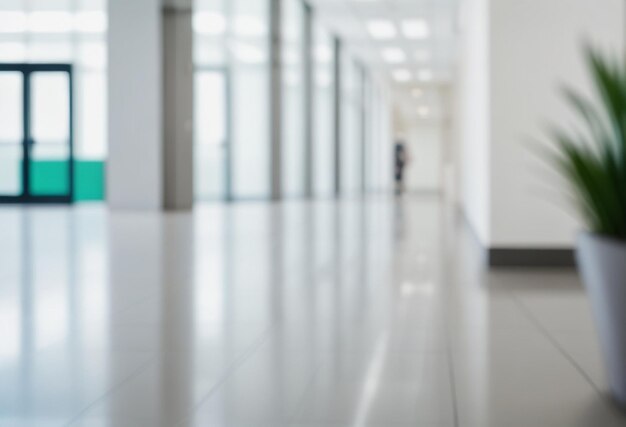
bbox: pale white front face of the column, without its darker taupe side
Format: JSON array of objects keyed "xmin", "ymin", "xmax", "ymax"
[{"xmin": 106, "ymin": 0, "xmax": 163, "ymax": 209}]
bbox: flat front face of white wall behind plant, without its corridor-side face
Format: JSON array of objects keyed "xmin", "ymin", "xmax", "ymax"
[{"xmin": 490, "ymin": 0, "xmax": 626, "ymax": 247}]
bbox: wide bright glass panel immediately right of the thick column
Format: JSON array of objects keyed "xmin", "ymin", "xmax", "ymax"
[{"xmin": 193, "ymin": 0, "xmax": 270, "ymax": 199}]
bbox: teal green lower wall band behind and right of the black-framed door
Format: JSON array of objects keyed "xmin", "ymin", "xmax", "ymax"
[{"xmin": 31, "ymin": 160, "xmax": 104, "ymax": 202}]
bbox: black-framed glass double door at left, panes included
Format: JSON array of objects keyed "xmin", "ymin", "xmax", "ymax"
[{"xmin": 0, "ymin": 64, "xmax": 74, "ymax": 203}]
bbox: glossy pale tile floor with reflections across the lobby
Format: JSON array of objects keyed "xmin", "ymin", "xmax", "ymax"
[{"xmin": 0, "ymin": 196, "xmax": 626, "ymax": 427}]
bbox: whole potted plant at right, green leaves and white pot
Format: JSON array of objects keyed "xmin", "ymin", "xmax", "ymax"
[{"xmin": 552, "ymin": 48, "xmax": 626, "ymax": 405}]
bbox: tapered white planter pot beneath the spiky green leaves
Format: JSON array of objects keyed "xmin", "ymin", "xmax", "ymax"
[{"xmin": 578, "ymin": 233, "xmax": 626, "ymax": 405}]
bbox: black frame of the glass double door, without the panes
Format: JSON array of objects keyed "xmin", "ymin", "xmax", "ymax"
[{"xmin": 0, "ymin": 63, "xmax": 74, "ymax": 204}]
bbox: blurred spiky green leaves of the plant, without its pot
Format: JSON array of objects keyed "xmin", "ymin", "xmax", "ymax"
[{"xmin": 551, "ymin": 48, "xmax": 626, "ymax": 240}]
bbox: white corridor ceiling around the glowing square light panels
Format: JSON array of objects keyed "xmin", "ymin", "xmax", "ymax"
[{"xmin": 310, "ymin": 0, "xmax": 459, "ymax": 121}]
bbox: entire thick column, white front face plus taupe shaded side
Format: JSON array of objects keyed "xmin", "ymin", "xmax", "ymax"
[{"xmin": 106, "ymin": 0, "xmax": 193, "ymax": 210}]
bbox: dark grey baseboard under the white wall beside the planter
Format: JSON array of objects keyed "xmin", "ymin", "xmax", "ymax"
[{"xmin": 487, "ymin": 248, "xmax": 576, "ymax": 267}]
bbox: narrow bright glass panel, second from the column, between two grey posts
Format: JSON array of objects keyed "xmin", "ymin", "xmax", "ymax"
[{"xmin": 282, "ymin": 0, "xmax": 305, "ymax": 197}]
